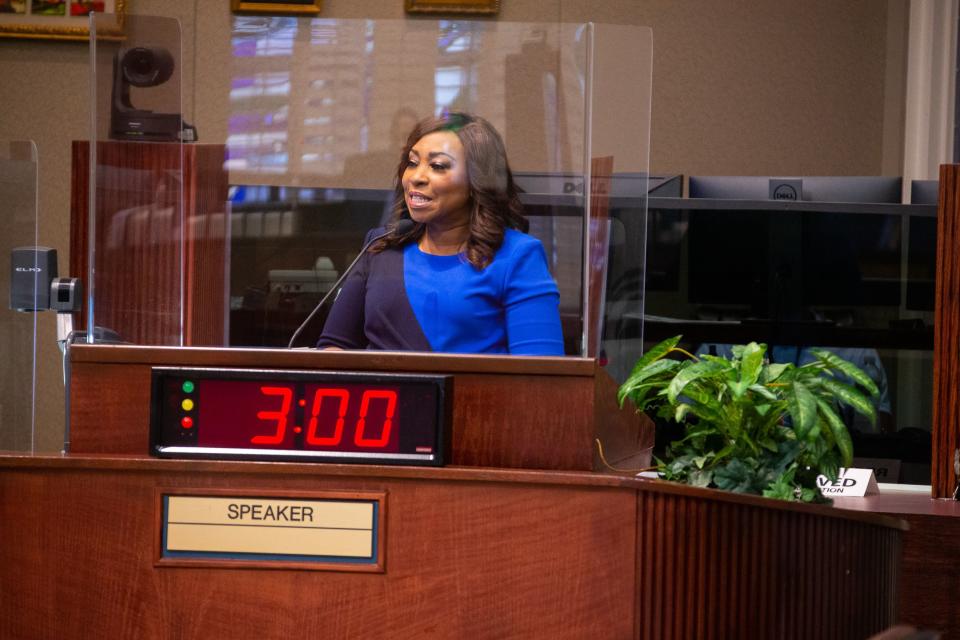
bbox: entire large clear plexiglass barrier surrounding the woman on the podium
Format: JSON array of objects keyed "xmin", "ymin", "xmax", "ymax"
[{"xmin": 84, "ymin": 16, "xmax": 652, "ymax": 380}]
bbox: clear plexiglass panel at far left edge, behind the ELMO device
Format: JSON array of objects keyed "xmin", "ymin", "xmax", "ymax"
[{"xmin": 0, "ymin": 140, "xmax": 39, "ymax": 452}]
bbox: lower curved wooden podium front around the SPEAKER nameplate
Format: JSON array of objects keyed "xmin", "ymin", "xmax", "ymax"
[{"xmin": 0, "ymin": 456, "xmax": 902, "ymax": 640}]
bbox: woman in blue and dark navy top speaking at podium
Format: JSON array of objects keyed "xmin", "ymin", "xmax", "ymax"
[{"xmin": 317, "ymin": 113, "xmax": 563, "ymax": 355}]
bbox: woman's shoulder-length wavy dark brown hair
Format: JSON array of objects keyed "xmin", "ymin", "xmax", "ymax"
[{"xmin": 371, "ymin": 112, "xmax": 530, "ymax": 269}]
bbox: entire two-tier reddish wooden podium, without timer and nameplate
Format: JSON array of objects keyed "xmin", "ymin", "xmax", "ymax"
[{"xmin": 0, "ymin": 345, "xmax": 904, "ymax": 639}]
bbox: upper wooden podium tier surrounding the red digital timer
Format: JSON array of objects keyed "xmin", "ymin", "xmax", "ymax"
[{"xmin": 63, "ymin": 344, "xmax": 653, "ymax": 471}]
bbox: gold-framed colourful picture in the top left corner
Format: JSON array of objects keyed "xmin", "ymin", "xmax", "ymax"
[{"xmin": 0, "ymin": 0, "xmax": 128, "ymax": 40}]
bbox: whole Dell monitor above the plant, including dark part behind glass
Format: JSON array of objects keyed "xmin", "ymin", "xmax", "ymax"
[{"xmin": 687, "ymin": 176, "xmax": 901, "ymax": 320}]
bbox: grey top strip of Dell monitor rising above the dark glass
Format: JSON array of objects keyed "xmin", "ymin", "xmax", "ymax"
[{"xmin": 689, "ymin": 176, "xmax": 903, "ymax": 203}]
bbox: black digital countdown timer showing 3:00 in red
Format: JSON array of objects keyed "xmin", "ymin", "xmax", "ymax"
[{"xmin": 150, "ymin": 367, "xmax": 452, "ymax": 466}]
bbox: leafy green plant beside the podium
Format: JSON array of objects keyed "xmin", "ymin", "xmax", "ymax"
[{"xmin": 618, "ymin": 336, "xmax": 878, "ymax": 502}]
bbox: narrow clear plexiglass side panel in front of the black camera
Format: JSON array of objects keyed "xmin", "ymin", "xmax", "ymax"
[{"xmin": 87, "ymin": 14, "xmax": 190, "ymax": 346}]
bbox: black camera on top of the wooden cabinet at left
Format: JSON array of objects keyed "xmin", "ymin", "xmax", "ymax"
[{"xmin": 110, "ymin": 47, "xmax": 196, "ymax": 142}]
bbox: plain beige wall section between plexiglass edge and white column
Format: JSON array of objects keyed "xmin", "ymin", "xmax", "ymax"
[{"xmin": 640, "ymin": 0, "xmax": 906, "ymax": 175}]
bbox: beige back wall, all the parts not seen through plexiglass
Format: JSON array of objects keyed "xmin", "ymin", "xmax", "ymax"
[{"xmin": 0, "ymin": 0, "xmax": 906, "ymax": 450}]
